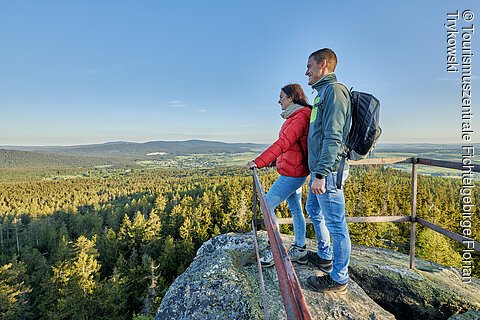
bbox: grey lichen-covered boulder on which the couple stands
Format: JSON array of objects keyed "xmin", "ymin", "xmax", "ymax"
[{"xmin": 156, "ymin": 232, "xmax": 394, "ymax": 320}]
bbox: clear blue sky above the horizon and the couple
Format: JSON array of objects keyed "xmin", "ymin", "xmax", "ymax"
[{"xmin": 0, "ymin": 0, "xmax": 480, "ymax": 145}]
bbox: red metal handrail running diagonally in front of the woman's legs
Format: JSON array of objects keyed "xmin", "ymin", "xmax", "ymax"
[{"xmin": 252, "ymin": 168, "xmax": 312, "ymax": 320}]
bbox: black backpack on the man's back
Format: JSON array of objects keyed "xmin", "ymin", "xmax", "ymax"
[{"xmin": 337, "ymin": 85, "xmax": 382, "ymax": 189}]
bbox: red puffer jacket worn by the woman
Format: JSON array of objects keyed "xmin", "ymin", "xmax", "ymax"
[{"xmin": 254, "ymin": 107, "xmax": 311, "ymax": 177}]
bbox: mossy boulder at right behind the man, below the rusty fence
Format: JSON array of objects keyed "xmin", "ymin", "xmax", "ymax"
[{"xmin": 350, "ymin": 246, "xmax": 480, "ymax": 319}]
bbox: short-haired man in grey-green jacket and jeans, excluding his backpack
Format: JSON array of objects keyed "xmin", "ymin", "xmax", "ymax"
[{"xmin": 305, "ymin": 48, "xmax": 351, "ymax": 293}]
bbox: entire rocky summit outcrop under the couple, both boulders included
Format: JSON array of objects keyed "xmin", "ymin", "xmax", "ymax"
[{"xmin": 156, "ymin": 232, "xmax": 480, "ymax": 320}]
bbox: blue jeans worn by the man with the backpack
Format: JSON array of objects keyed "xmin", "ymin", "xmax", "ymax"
[{"xmin": 305, "ymin": 171, "xmax": 351, "ymax": 284}]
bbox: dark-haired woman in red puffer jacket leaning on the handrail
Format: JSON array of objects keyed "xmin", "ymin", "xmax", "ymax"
[{"xmin": 247, "ymin": 84, "xmax": 311, "ymax": 267}]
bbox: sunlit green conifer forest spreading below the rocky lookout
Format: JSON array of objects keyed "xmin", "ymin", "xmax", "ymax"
[{"xmin": 0, "ymin": 166, "xmax": 480, "ymax": 320}]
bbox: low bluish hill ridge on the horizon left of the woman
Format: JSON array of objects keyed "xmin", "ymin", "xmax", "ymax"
[{"xmin": 0, "ymin": 140, "xmax": 266, "ymax": 158}]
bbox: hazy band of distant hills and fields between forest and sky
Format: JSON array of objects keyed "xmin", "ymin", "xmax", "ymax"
[{"xmin": 0, "ymin": 140, "xmax": 472, "ymax": 168}]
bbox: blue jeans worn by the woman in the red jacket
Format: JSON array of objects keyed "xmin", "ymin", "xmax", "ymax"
[{"xmin": 265, "ymin": 175, "xmax": 307, "ymax": 247}]
